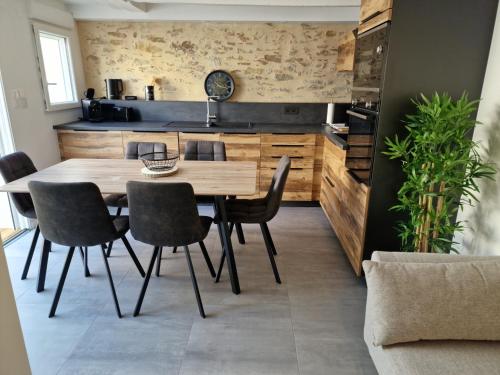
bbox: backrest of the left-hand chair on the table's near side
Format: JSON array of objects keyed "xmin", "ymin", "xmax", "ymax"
[{"xmin": 28, "ymin": 181, "xmax": 116, "ymax": 246}]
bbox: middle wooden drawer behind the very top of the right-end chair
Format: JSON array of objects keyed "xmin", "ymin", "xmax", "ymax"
[{"xmin": 261, "ymin": 145, "xmax": 315, "ymax": 168}]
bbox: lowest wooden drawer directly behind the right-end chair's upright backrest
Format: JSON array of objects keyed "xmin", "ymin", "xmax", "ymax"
[{"xmin": 260, "ymin": 168, "xmax": 313, "ymax": 201}]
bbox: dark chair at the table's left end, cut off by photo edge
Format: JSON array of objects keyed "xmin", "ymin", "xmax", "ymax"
[{"xmin": 0, "ymin": 152, "xmax": 44, "ymax": 280}]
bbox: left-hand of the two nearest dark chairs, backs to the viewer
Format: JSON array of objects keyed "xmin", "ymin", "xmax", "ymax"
[{"xmin": 28, "ymin": 181, "xmax": 145, "ymax": 318}]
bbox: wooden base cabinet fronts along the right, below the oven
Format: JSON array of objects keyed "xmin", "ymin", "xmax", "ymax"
[{"xmin": 320, "ymin": 140, "xmax": 370, "ymax": 276}]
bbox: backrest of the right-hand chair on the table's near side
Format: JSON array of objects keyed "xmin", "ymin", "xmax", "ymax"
[{"xmin": 127, "ymin": 181, "xmax": 207, "ymax": 246}]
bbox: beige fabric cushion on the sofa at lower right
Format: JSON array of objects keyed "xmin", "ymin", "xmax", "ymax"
[{"xmin": 363, "ymin": 261, "xmax": 500, "ymax": 346}]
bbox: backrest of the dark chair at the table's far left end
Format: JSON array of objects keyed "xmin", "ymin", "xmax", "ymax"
[{"xmin": 0, "ymin": 152, "xmax": 37, "ymax": 215}]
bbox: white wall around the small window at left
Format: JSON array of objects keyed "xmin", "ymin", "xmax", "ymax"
[{"xmin": 0, "ymin": 0, "xmax": 85, "ymax": 168}]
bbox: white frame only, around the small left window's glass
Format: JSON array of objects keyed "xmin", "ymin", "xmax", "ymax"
[{"xmin": 32, "ymin": 22, "xmax": 80, "ymax": 112}]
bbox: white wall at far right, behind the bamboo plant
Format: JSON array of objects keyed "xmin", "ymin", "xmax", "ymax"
[{"xmin": 455, "ymin": 8, "xmax": 500, "ymax": 255}]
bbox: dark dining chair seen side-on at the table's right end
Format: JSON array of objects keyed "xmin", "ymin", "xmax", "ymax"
[{"xmin": 215, "ymin": 156, "xmax": 290, "ymax": 284}]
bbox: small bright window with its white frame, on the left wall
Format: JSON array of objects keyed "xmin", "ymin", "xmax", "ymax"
[{"xmin": 33, "ymin": 24, "xmax": 78, "ymax": 111}]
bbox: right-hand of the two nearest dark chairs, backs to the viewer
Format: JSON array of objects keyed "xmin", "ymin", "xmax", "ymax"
[{"xmin": 127, "ymin": 181, "xmax": 215, "ymax": 318}]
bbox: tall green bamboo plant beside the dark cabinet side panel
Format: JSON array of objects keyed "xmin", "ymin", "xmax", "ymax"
[{"xmin": 384, "ymin": 93, "xmax": 496, "ymax": 253}]
